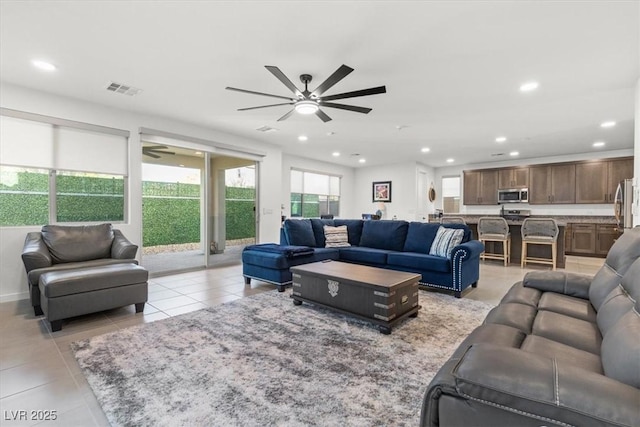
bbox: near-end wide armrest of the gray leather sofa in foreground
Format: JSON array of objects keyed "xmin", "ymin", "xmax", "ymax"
[{"xmin": 452, "ymin": 344, "xmax": 640, "ymax": 426}]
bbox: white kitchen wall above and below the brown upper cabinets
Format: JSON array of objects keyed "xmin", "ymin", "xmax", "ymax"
[{"xmin": 436, "ymin": 150, "xmax": 638, "ymax": 216}]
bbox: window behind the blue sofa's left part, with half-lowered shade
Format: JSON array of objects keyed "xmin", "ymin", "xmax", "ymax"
[{"xmin": 291, "ymin": 169, "xmax": 340, "ymax": 218}]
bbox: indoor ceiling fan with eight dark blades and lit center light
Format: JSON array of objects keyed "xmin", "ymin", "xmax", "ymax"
[{"xmin": 225, "ymin": 65, "xmax": 387, "ymax": 122}]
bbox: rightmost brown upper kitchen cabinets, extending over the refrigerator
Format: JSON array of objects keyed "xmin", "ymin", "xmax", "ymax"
[{"xmin": 576, "ymin": 158, "xmax": 633, "ymax": 203}]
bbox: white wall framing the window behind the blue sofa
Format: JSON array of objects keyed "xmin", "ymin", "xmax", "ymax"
[{"xmin": 282, "ymin": 154, "xmax": 360, "ymax": 221}]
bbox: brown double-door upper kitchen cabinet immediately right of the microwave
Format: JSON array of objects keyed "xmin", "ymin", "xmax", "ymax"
[{"xmin": 529, "ymin": 163, "xmax": 576, "ymax": 205}]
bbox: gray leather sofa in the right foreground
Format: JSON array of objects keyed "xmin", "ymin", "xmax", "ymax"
[{"xmin": 420, "ymin": 227, "xmax": 640, "ymax": 426}]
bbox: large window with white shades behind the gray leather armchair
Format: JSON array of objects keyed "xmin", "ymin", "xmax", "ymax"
[{"xmin": 0, "ymin": 113, "xmax": 129, "ymax": 226}]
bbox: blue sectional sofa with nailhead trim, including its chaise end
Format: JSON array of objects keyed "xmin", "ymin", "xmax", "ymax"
[{"xmin": 242, "ymin": 219, "xmax": 484, "ymax": 298}]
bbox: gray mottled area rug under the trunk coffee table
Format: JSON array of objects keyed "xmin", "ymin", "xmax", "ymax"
[{"xmin": 72, "ymin": 290, "xmax": 491, "ymax": 426}]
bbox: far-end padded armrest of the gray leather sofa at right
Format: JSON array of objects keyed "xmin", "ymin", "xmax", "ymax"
[{"xmin": 522, "ymin": 271, "xmax": 593, "ymax": 299}]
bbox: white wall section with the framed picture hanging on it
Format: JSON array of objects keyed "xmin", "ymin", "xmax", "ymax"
[{"xmin": 353, "ymin": 162, "xmax": 435, "ymax": 221}]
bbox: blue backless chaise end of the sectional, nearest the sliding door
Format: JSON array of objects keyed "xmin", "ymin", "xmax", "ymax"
[{"xmin": 242, "ymin": 243, "xmax": 340, "ymax": 292}]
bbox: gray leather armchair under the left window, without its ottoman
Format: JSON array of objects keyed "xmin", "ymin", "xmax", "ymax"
[{"xmin": 22, "ymin": 224, "xmax": 138, "ymax": 316}]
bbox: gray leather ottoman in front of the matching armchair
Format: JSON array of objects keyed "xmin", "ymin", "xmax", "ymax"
[{"xmin": 38, "ymin": 264, "xmax": 149, "ymax": 332}]
